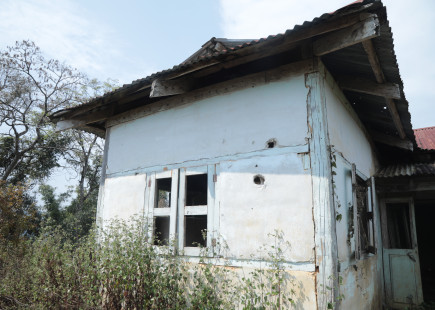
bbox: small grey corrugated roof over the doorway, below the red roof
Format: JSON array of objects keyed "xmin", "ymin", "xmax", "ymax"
[{"xmin": 375, "ymin": 163, "xmax": 435, "ymax": 178}]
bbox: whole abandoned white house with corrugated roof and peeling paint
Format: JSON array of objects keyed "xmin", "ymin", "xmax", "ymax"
[{"xmin": 52, "ymin": 0, "xmax": 435, "ymax": 309}]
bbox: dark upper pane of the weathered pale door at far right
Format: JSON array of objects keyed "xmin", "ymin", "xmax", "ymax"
[{"xmin": 386, "ymin": 203, "xmax": 412, "ymax": 249}]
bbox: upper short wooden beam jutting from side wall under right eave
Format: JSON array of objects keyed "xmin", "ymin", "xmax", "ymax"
[{"xmin": 337, "ymin": 76, "xmax": 401, "ymax": 99}]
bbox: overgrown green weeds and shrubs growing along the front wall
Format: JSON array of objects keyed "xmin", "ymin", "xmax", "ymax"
[{"xmin": 0, "ymin": 218, "xmax": 293, "ymax": 309}]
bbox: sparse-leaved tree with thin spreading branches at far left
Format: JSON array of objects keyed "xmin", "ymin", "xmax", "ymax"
[{"xmin": 0, "ymin": 41, "xmax": 87, "ymax": 181}]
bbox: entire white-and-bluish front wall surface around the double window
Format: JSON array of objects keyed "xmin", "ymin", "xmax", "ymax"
[{"xmin": 99, "ymin": 67, "xmax": 316, "ymax": 309}]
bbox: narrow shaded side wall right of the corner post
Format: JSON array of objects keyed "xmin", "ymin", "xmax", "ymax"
[{"xmin": 325, "ymin": 74, "xmax": 382, "ymax": 309}]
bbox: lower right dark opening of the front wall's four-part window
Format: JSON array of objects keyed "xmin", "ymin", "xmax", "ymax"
[{"xmin": 185, "ymin": 215, "xmax": 207, "ymax": 247}]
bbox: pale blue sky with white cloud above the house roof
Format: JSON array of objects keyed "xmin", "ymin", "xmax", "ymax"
[{"xmin": 0, "ymin": 0, "xmax": 435, "ymax": 128}]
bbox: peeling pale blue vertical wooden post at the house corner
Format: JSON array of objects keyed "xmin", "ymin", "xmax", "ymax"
[{"xmin": 305, "ymin": 59, "xmax": 338, "ymax": 309}]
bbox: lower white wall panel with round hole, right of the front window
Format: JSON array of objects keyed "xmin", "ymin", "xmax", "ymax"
[{"xmin": 220, "ymin": 153, "xmax": 314, "ymax": 264}]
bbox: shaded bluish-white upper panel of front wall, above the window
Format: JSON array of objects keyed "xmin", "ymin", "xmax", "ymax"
[{"xmin": 107, "ymin": 74, "xmax": 307, "ymax": 175}]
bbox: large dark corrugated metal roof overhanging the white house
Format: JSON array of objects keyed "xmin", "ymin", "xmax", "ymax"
[{"xmin": 51, "ymin": 0, "xmax": 415, "ymax": 162}]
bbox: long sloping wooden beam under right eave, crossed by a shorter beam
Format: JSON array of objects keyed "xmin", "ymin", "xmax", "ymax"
[{"xmin": 362, "ymin": 40, "xmax": 406, "ymax": 139}]
